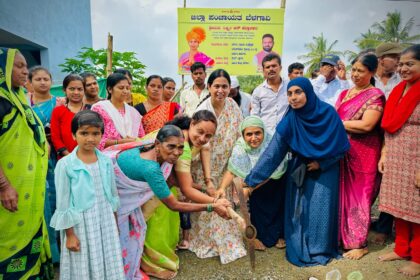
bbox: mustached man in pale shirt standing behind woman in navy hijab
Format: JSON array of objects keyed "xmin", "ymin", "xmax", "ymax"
[{"xmin": 251, "ymin": 54, "xmax": 289, "ymax": 132}]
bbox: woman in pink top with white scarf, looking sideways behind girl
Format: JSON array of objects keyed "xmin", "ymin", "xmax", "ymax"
[{"xmin": 92, "ymin": 73, "xmax": 145, "ymax": 150}]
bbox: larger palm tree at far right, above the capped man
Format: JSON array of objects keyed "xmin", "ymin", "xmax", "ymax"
[{"xmin": 355, "ymin": 11, "xmax": 420, "ymax": 50}]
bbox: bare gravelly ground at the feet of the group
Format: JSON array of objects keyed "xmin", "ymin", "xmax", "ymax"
[{"xmin": 171, "ymin": 234, "xmax": 414, "ymax": 280}]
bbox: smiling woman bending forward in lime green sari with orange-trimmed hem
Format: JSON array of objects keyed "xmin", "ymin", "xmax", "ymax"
[{"xmin": 141, "ymin": 110, "xmax": 223, "ymax": 278}]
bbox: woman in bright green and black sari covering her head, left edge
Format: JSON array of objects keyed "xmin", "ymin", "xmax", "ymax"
[{"xmin": 0, "ymin": 48, "xmax": 54, "ymax": 279}]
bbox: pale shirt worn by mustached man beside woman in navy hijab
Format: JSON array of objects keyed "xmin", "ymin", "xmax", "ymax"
[{"xmin": 251, "ymin": 79, "xmax": 289, "ymax": 132}]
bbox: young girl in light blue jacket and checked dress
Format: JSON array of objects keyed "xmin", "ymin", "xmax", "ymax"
[{"xmin": 51, "ymin": 110, "xmax": 125, "ymax": 280}]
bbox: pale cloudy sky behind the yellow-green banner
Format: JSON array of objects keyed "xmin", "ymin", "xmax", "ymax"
[{"xmin": 91, "ymin": 0, "xmax": 420, "ymax": 84}]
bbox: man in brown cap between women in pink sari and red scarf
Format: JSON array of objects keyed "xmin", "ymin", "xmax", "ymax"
[{"xmin": 375, "ymin": 43, "xmax": 403, "ymax": 99}]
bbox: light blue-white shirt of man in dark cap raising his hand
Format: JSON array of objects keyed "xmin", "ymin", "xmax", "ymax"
[{"xmin": 311, "ymin": 75, "xmax": 351, "ymax": 107}]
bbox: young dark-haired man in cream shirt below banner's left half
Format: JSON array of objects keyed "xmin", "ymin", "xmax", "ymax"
[{"xmin": 179, "ymin": 62, "xmax": 209, "ymax": 117}]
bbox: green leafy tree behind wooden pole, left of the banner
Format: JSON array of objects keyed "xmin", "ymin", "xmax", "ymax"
[{"xmin": 59, "ymin": 47, "xmax": 146, "ymax": 93}]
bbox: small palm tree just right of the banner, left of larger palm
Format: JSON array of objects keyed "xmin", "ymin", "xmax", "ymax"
[{"xmin": 298, "ymin": 33, "xmax": 342, "ymax": 73}]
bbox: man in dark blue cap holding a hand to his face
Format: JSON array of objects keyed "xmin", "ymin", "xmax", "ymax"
[{"xmin": 311, "ymin": 54, "xmax": 350, "ymax": 106}]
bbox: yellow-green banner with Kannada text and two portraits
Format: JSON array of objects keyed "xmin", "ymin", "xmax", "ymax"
[{"xmin": 178, "ymin": 8, "xmax": 284, "ymax": 75}]
